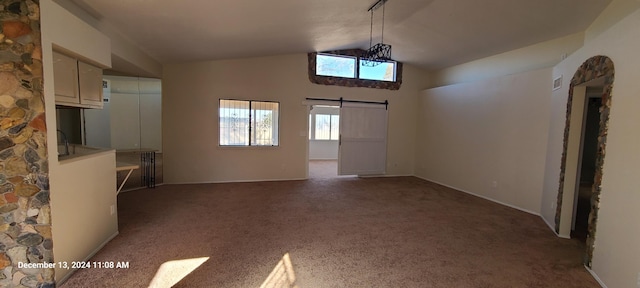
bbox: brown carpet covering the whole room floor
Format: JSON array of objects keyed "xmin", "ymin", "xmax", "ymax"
[{"xmin": 61, "ymin": 177, "xmax": 599, "ymax": 288}]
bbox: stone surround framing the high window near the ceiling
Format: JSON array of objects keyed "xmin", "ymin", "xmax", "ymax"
[{"xmin": 307, "ymin": 49, "xmax": 402, "ymax": 90}]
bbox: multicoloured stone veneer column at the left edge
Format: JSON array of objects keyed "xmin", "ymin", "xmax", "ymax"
[{"xmin": 0, "ymin": 0, "xmax": 55, "ymax": 287}]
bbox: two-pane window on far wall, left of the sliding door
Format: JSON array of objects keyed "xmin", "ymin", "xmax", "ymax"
[{"xmin": 218, "ymin": 99, "xmax": 280, "ymax": 146}]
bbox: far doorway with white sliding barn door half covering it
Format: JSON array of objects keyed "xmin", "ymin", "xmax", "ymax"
[{"xmin": 305, "ymin": 98, "xmax": 389, "ymax": 178}]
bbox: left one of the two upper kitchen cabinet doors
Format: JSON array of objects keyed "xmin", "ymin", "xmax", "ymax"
[{"xmin": 53, "ymin": 52, "xmax": 80, "ymax": 104}]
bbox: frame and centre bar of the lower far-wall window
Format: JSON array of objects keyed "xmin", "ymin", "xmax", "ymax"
[{"xmin": 217, "ymin": 98, "xmax": 280, "ymax": 148}]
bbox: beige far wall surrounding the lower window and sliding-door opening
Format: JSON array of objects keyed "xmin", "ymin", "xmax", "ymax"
[{"xmin": 162, "ymin": 54, "xmax": 427, "ymax": 183}]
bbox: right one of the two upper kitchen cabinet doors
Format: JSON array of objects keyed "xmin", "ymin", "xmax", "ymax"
[{"xmin": 78, "ymin": 61, "xmax": 102, "ymax": 108}]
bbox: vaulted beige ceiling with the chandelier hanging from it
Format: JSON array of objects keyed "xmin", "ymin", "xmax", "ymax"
[{"xmin": 72, "ymin": 0, "xmax": 611, "ymax": 69}]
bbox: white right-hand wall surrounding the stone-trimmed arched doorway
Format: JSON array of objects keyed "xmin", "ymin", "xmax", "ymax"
[{"xmin": 416, "ymin": 0, "xmax": 640, "ymax": 287}]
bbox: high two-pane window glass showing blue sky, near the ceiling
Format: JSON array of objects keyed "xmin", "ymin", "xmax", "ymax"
[{"xmin": 316, "ymin": 54, "xmax": 397, "ymax": 82}]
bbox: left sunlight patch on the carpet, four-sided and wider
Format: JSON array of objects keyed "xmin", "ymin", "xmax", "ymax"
[{"xmin": 149, "ymin": 257, "xmax": 209, "ymax": 288}]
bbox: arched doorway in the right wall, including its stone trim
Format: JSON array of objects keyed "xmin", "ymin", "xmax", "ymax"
[{"xmin": 555, "ymin": 56, "xmax": 614, "ymax": 268}]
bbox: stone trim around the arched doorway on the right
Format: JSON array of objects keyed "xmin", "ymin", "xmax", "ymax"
[{"xmin": 555, "ymin": 56, "xmax": 614, "ymax": 267}]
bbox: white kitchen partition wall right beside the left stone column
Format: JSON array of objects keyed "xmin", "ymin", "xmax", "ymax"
[{"xmin": 40, "ymin": 0, "xmax": 118, "ymax": 281}]
